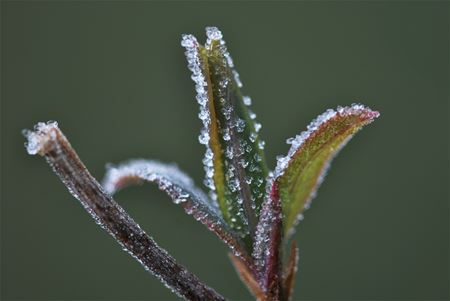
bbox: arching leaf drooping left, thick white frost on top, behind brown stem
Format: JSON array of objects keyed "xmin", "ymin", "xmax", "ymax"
[{"xmin": 103, "ymin": 160, "xmax": 250, "ymax": 262}]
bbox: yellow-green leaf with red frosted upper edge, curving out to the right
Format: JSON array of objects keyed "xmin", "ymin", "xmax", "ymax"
[{"xmin": 273, "ymin": 104, "xmax": 379, "ymax": 237}]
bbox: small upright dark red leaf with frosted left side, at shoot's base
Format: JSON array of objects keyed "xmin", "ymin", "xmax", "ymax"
[{"xmin": 253, "ymin": 186, "xmax": 283, "ymax": 300}]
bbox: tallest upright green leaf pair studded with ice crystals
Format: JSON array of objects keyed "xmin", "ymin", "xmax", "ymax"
[{"xmin": 182, "ymin": 27, "xmax": 267, "ymax": 241}]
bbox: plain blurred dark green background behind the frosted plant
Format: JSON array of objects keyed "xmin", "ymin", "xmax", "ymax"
[{"xmin": 1, "ymin": 1, "xmax": 449, "ymax": 300}]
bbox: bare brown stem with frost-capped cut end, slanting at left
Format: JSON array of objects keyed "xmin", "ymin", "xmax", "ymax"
[{"xmin": 25, "ymin": 122, "xmax": 225, "ymax": 300}]
